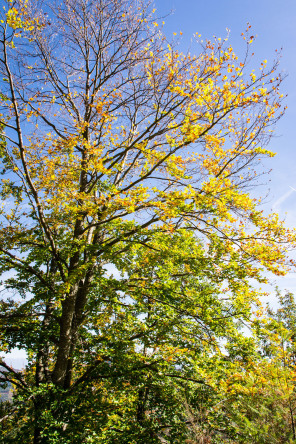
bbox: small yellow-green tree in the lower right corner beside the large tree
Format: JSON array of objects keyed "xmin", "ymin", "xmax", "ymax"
[{"xmin": 217, "ymin": 289, "xmax": 295, "ymax": 443}]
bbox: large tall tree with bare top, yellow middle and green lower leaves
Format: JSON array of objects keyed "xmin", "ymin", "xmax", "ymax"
[{"xmin": 0, "ymin": 0, "xmax": 294, "ymax": 443}]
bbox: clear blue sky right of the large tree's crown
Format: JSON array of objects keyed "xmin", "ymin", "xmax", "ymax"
[{"xmin": 155, "ymin": 0, "xmax": 296, "ymax": 303}]
